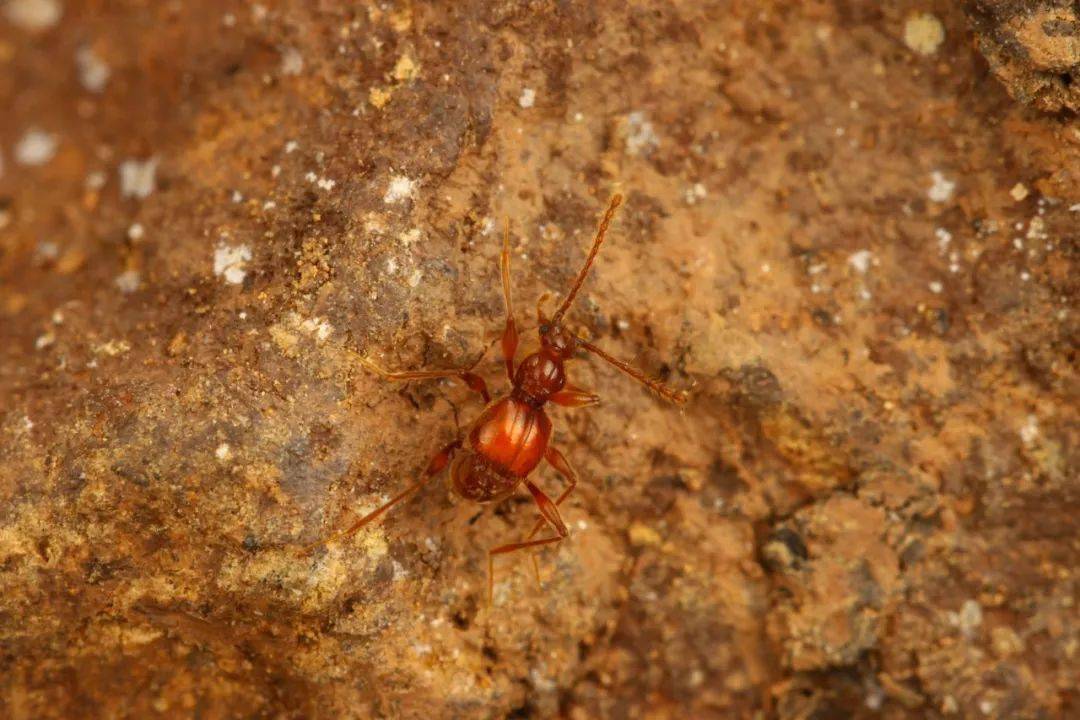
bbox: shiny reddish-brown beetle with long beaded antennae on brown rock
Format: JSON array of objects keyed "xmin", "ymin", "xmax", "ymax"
[{"xmin": 308, "ymin": 195, "xmax": 687, "ymax": 601}]
